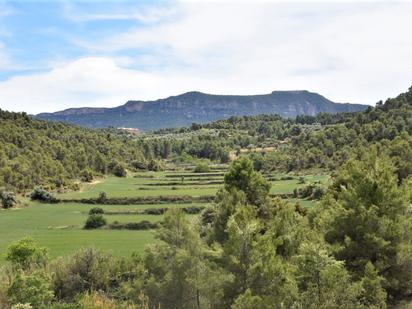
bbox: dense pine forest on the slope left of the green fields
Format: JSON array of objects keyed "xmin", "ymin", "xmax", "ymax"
[{"xmin": 0, "ymin": 110, "xmax": 144, "ymax": 192}]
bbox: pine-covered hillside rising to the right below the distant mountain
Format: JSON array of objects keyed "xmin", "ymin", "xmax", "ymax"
[{"xmin": 146, "ymin": 87, "xmax": 412, "ymax": 174}]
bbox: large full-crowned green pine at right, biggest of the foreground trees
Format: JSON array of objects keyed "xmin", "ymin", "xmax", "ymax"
[{"xmin": 318, "ymin": 149, "xmax": 412, "ymax": 295}]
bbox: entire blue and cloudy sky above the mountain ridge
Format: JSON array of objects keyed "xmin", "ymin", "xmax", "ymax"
[{"xmin": 0, "ymin": 0, "xmax": 412, "ymax": 114}]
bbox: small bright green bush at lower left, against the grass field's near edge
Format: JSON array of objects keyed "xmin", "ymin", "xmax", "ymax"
[{"xmin": 6, "ymin": 237, "xmax": 47, "ymax": 270}]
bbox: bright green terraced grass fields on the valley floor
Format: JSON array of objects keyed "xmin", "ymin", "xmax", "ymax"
[{"xmin": 0, "ymin": 171, "xmax": 329, "ymax": 262}]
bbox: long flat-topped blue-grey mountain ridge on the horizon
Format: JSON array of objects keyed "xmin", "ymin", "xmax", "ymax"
[{"xmin": 35, "ymin": 90, "xmax": 367, "ymax": 131}]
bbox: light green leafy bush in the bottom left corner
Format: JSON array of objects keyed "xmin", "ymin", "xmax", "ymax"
[{"xmin": 7, "ymin": 271, "xmax": 53, "ymax": 308}]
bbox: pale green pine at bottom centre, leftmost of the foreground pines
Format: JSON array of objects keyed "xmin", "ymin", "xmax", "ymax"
[{"xmin": 140, "ymin": 209, "xmax": 231, "ymax": 309}]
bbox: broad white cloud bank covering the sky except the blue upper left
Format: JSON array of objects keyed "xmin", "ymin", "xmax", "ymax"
[{"xmin": 0, "ymin": 2, "xmax": 412, "ymax": 112}]
